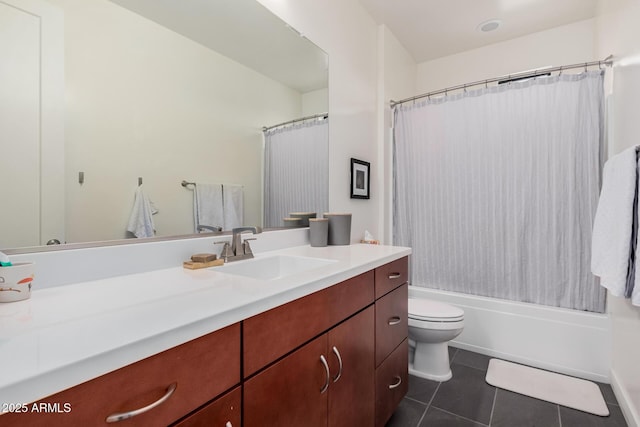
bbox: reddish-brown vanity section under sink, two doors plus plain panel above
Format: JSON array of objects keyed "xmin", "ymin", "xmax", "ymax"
[{"xmin": 243, "ymin": 271, "xmax": 375, "ymax": 427}]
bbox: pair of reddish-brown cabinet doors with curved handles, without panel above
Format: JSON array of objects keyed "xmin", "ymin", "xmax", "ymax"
[{"xmin": 244, "ymin": 306, "xmax": 375, "ymax": 427}]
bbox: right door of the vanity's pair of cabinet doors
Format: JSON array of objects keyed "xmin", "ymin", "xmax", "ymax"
[{"xmin": 327, "ymin": 306, "xmax": 375, "ymax": 427}]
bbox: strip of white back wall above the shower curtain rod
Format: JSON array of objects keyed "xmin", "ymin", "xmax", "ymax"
[{"xmin": 416, "ymin": 19, "xmax": 602, "ymax": 93}]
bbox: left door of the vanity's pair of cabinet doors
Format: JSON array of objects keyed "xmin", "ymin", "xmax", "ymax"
[{"xmin": 243, "ymin": 334, "xmax": 330, "ymax": 427}]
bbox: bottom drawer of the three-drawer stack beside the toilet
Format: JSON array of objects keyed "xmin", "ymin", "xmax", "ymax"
[{"xmin": 376, "ymin": 340, "xmax": 409, "ymax": 427}]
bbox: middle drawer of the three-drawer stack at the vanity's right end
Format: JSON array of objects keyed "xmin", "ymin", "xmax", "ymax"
[{"xmin": 376, "ymin": 283, "xmax": 409, "ymax": 366}]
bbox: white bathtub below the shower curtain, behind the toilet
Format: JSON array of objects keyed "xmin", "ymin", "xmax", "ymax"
[{"xmin": 409, "ymin": 286, "xmax": 611, "ymax": 383}]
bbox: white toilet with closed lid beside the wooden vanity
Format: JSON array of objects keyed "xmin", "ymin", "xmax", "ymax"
[{"xmin": 409, "ymin": 297, "xmax": 464, "ymax": 381}]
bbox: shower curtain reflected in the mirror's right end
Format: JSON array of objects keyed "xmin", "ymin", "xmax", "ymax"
[{"xmin": 264, "ymin": 119, "xmax": 329, "ymax": 227}]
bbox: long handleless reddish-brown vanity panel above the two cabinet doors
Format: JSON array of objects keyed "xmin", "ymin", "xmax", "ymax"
[{"xmin": 242, "ymin": 271, "xmax": 374, "ymax": 378}]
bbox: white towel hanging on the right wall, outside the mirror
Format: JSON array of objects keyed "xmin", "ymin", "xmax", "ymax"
[{"xmin": 591, "ymin": 147, "xmax": 640, "ymax": 303}]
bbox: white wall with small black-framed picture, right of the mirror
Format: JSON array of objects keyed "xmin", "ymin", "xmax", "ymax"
[{"xmin": 259, "ymin": 0, "xmax": 384, "ymax": 241}]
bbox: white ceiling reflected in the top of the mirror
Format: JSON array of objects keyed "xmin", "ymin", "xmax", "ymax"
[{"xmin": 111, "ymin": 0, "xmax": 328, "ymax": 93}]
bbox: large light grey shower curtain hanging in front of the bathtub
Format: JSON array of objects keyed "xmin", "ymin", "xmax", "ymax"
[{"xmin": 393, "ymin": 71, "xmax": 605, "ymax": 312}]
